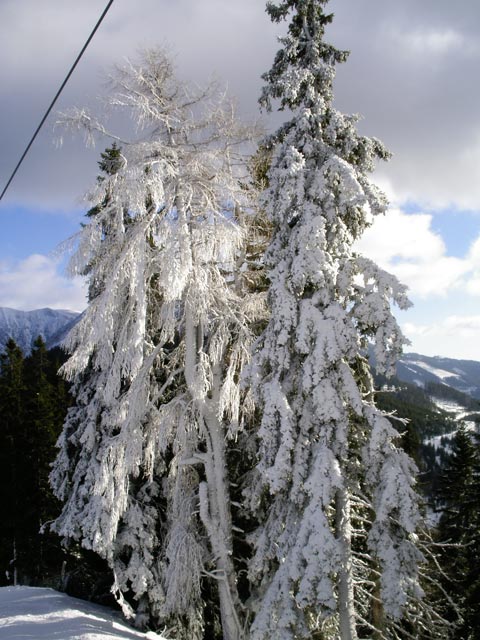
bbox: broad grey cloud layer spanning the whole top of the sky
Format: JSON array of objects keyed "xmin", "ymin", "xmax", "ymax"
[{"xmin": 0, "ymin": 0, "xmax": 480, "ymax": 210}]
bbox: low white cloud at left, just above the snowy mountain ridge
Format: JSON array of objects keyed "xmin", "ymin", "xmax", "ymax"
[{"xmin": 0, "ymin": 254, "xmax": 86, "ymax": 311}]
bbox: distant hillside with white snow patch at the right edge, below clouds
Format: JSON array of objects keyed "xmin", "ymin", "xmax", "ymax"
[{"xmin": 397, "ymin": 353, "xmax": 480, "ymax": 399}]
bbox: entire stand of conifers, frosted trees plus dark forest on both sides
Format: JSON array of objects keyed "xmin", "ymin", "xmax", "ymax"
[{"xmin": 0, "ymin": 0, "xmax": 480, "ymax": 640}]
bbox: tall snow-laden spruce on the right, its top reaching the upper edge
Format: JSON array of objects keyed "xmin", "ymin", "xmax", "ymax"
[{"xmin": 249, "ymin": 0, "xmax": 430, "ymax": 640}]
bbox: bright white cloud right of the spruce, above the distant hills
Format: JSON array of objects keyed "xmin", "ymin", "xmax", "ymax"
[{"xmin": 357, "ymin": 209, "xmax": 480, "ymax": 360}]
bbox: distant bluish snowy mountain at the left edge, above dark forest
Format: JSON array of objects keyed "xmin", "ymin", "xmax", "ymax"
[{"xmin": 0, "ymin": 307, "xmax": 79, "ymax": 354}]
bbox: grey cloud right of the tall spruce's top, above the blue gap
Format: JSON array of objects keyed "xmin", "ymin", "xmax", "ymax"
[{"xmin": 331, "ymin": 0, "xmax": 480, "ymax": 210}]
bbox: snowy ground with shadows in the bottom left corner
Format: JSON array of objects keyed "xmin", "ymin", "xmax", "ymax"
[{"xmin": 0, "ymin": 587, "xmax": 167, "ymax": 640}]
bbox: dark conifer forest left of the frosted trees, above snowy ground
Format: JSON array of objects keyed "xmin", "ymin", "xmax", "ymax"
[{"xmin": 0, "ymin": 336, "xmax": 113, "ymax": 603}]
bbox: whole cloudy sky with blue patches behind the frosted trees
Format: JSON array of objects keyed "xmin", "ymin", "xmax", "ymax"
[{"xmin": 0, "ymin": 0, "xmax": 480, "ymax": 360}]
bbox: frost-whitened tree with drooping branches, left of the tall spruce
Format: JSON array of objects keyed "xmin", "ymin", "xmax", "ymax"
[{"xmin": 52, "ymin": 51, "xmax": 261, "ymax": 640}]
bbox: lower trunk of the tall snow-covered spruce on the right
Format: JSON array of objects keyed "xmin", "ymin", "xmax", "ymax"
[{"xmin": 335, "ymin": 488, "xmax": 357, "ymax": 640}]
